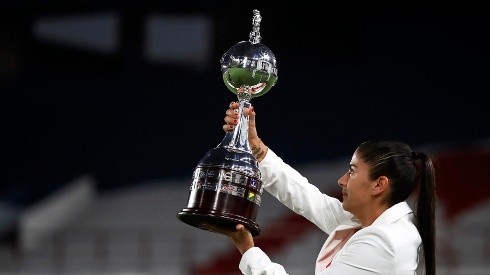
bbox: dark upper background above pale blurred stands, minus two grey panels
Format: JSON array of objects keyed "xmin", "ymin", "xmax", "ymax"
[{"xmin": 0, "ymin": 0, "xmax": 490, "ymax": 205}]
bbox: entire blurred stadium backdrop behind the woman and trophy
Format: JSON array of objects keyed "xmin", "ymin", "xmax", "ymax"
[{"xmin": 0, "ymin": 0, "xmax": 490, "ymax": 274}]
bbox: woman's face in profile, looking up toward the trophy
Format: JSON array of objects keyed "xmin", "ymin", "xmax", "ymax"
[{"xmin": 338, "ymin": 153, "xmax": 372, "ymax": 216}]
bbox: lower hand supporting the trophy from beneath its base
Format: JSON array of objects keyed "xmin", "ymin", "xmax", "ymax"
[{"xmin": 199, "ymin": 223, "xmax": 255, "ymax": 255}]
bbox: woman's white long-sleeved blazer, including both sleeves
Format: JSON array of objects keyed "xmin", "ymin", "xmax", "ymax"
[{"xmin": 239, "ymin": 148, "xmax": 421, "ymax": 275}]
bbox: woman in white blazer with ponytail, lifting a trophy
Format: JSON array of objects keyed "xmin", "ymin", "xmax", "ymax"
[{"xmin": 203, "ymin": 102, "xmax": 436, "ymax": 275}]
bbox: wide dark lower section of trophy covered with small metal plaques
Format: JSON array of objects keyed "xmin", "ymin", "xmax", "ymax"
[{"xmin": 177, "ymin": 144, "xmax": 262, "ymax": 236}]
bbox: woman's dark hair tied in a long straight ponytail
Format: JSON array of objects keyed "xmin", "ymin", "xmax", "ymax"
[{"xmin": 356, "ymin": 141, "xmax": 436, "ymax": 275}]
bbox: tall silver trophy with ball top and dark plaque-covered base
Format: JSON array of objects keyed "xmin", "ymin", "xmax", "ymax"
[{"xmin": 177, "ymin": 10, "xmax": 277, "ymax": 236}]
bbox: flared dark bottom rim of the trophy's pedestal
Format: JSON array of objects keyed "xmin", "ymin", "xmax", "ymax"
[{"xmin": 177, "ymin": 209, "xmax": 260, "ymax": 237}]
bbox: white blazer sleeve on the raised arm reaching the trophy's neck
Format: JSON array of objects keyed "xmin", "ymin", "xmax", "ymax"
[{"xmin": 259, "ymin": 148, "xmax": 358, "ymax": 234}]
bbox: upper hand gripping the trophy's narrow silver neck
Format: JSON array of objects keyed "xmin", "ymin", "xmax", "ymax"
[{"xmin": 223, "ymin": 101, "xmax": 268, "ymax": 162}]
